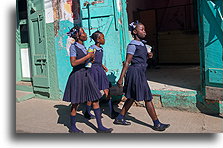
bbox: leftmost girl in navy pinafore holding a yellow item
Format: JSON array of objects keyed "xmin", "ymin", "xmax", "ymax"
[{"xmin": 63, "ymin": 26, "xmax": 113, "ymax": 133}]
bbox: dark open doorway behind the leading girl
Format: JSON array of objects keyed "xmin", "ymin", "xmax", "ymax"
[{"xmin": 127, "ymin": 0, "xmax": 201, "ymax": 91}]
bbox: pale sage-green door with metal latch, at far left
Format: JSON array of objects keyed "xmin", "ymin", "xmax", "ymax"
[{"xmin": 27, "ymin": 0, "xmax": 49, "ymax": 92}]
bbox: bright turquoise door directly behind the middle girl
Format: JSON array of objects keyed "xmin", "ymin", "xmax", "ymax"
[{"xmin": 80, "ymin": 0, "xmax": 128, "ymax": 83}]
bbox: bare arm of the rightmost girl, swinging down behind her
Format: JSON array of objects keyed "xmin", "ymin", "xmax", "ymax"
[{"xmin": 117, "ymin": 54, "xmax": 133, "ymax": 87}]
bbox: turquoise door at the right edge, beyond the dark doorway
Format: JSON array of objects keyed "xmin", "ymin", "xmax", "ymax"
[{"xmin": 198, "ymin": 0, "xmax": 223, "ymax": 100}]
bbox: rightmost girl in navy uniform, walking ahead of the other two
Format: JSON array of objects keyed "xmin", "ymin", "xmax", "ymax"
[{"xmin": 113, "ymin": 22, "xmax": 170, "ymax": 131}]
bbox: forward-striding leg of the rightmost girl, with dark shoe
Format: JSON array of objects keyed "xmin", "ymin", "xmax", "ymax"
[{"xmin": 145, "ymin": 101, "xmax": 170, "ymax": 131}]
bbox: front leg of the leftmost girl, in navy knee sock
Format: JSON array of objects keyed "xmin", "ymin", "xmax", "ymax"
[{"xmin": 92, "ymin": 101, "xmax": 113, "ymax": 133}]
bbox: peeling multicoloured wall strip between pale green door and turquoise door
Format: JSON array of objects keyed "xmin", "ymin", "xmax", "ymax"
[{"xmin": 44, "ymin": 0, "xmax": 73, "ymax": 98}]
